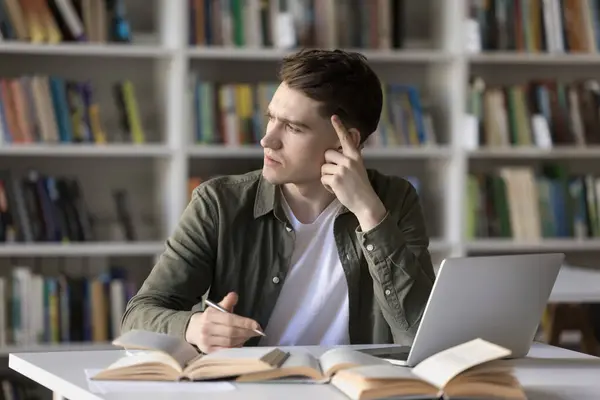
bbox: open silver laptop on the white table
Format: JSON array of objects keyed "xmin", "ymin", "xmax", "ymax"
[{"xmin": 363, "ymin": 253, "xmax": 565, "ymax": 367}]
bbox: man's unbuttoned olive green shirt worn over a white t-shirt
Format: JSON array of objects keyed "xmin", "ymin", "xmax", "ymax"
[{"xmin": 122, "ymin": 170, "xmax": 435, "ymax": 346}]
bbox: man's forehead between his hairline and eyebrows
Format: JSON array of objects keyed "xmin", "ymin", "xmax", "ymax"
[{"xmin": 269, "ymin": 82, "xmax": 323, "ymax": 121}]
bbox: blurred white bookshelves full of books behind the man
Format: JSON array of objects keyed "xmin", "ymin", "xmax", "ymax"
[{"xmin": 0, "ymin": 0, "xmax": 600, "ymax": 398}]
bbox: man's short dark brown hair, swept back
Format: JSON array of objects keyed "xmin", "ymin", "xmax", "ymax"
[{"xmin": 278, "ymin": 49, "xmax": 383, "ymax": 143}]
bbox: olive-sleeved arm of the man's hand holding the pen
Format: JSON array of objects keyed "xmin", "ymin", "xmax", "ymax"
[{"xmin": 121, "ymin": 186, "xmax": 217, "ymax": 339}]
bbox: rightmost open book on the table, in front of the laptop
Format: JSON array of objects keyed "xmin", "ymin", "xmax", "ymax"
[{"xmin": 331, "ymin": 339, "xmax": 527, "ymax": 400}]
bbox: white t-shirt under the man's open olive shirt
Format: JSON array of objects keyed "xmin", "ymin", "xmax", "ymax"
[{"xmin": 260, "ymin": 196, "xmax": 350, "ymax": 346}]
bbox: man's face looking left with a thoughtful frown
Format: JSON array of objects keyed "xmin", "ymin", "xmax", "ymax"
[{"xmin": 260, "ymin": 83, "xmax": 337, "ymax": 184}]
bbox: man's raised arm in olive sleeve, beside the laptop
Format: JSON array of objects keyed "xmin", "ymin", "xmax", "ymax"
[{"xmin": 357, "ymin": 184, "xmax": 435, "ymax": 344}]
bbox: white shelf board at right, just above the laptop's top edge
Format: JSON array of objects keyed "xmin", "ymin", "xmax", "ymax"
[{"xmin": 465, "ymin": 238, "xmax": 600, "ymax": 253}]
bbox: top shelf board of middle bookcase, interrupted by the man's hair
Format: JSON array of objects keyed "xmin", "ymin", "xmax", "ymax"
[{"xmin": 187, "ymin": 46, "xmax": 453, "ymax": 63}]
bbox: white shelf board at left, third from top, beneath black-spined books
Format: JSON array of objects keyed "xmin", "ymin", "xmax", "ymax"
[{"xmin": 0, "ymin": 242, "xmax": 164, "ymax": 257}]
